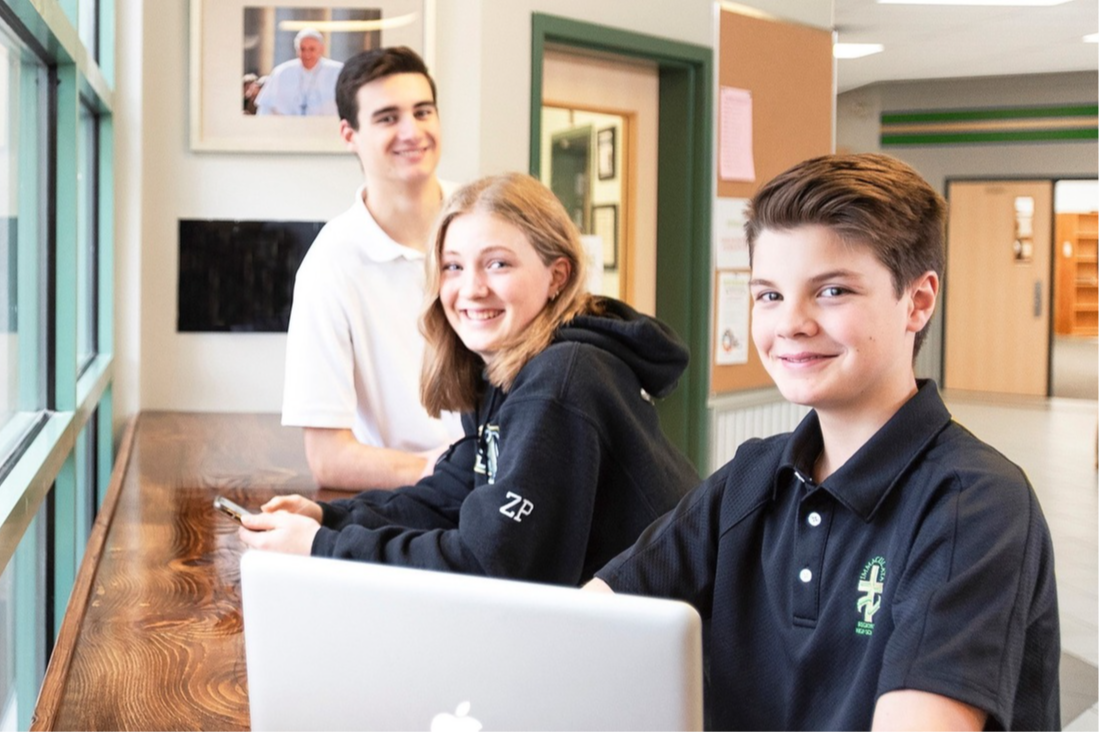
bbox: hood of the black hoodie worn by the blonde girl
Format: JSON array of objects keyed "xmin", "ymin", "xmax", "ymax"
[{"xmin": 555, "ymin": 298, "xmax": 690, "ymax": 397}]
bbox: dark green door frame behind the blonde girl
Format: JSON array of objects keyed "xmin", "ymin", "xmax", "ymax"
[{"xmin": 530, "ymin": 13, "xmax": 713, "ymax": 474}]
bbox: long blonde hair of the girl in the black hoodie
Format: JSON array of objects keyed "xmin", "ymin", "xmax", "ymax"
[{"xmin": 420, "ymin": 173, "xmax": 599, "ymax": 417}]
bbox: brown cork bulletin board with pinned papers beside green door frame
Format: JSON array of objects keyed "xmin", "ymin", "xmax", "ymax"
[{"xmin": 710, "ymin": 9, "xmax": 834, "ymax": 395}]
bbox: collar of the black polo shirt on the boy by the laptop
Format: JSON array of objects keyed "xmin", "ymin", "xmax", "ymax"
[{"xmin": 774, "ymin": 379, "xmax": 951, "ymax": 521}]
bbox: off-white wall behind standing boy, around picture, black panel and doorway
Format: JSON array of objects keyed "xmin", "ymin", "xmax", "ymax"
[{"xmin": 114, "ymin": 0, "xmax": 832, "ymax": 428}]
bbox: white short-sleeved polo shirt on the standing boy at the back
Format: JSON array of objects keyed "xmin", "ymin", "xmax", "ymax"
[{"xmin": 282, "ymin": 184, "xmax": 462, "ymax": 452}]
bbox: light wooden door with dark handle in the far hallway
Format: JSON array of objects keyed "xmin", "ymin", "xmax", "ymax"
[{"xmin": 943, "ymin": 180, "xmax": 1053, "ymax": 396}]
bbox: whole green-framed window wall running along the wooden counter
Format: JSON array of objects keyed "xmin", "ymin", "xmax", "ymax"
[{"xmin": 0, "ymin": 0, "xmax": 114, "ymax": 732}]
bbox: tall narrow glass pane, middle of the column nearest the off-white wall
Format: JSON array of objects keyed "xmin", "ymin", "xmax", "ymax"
[{"xmin": 76, "ymin": 104, "xmax": 99, "ymax": 373}]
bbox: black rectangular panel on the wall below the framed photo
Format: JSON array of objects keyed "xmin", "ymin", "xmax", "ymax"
[{"xmin": 177, "ymin": 220, "xmax": 323, "ymax": 333}]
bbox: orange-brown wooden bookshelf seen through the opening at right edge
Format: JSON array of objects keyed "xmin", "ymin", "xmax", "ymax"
[{"xmin": 1054, "ymin": 211, "xmax": 1099, "ymax": 335}]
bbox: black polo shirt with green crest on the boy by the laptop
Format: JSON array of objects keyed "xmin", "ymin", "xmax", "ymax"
[{"xmin": 597, "ymin": 381, "xmax": 1061, "ymax": 732}]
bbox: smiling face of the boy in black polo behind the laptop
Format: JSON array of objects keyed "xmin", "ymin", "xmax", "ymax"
[{"xmin": 751, "ymin": 225, "xmax": 939, "ymax": 419}]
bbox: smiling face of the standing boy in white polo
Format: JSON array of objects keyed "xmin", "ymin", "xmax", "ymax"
[{"xmin": 340, "ymin": 74, "xmax": 440, "ymax": 188}]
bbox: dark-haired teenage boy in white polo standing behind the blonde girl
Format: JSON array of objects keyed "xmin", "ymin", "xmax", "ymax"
[{"xmin": 282, "ymin": 47, "xmax": 462, "ymax": 490}]
